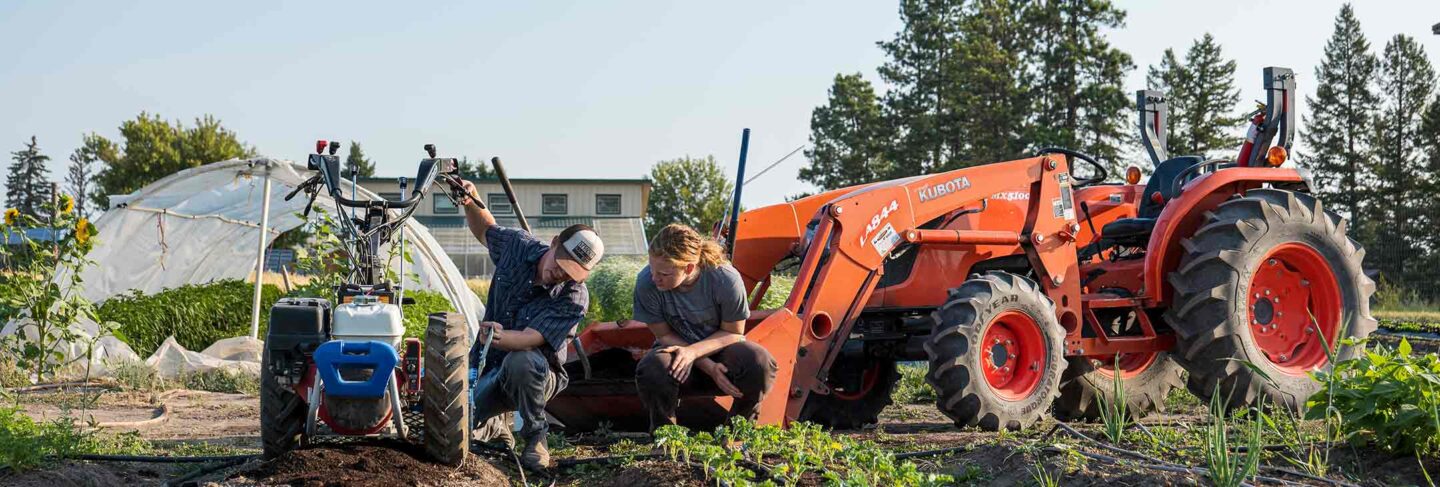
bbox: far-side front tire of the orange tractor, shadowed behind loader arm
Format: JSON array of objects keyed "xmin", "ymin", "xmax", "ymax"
[{"xmin": 801, "ymin": 362, "xmax": 900, "ymax": 429}]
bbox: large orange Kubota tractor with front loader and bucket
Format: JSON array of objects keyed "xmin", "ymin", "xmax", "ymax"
[{"xmin": 549, "ymin": 68, "xmax": 1375, "ymax": 429}]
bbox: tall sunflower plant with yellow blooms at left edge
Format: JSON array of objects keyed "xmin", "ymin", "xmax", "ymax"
[{"xmin": 0, "ymin": 196, "xmax": 109, "ymax": 380}]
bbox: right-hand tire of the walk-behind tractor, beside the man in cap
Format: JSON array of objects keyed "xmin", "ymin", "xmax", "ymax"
[{"xmin": 420, "ymin": 313, "xmax": 471, "ymax": 465}]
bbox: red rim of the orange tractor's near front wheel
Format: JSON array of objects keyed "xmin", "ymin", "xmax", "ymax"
[{"xmin": 976, "ymin": 311, "xmax": 1045, "ymax": 401}]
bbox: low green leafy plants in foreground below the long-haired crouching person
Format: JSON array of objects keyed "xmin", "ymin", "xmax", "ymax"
[{"xmin": 655, "ymin": 418, "xmax": 953, "ymax": 486}]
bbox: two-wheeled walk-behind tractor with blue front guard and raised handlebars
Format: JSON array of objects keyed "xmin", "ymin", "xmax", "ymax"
[{"xmin": 261, "ymin": 141, "xmax": 471, "ymax": 464}]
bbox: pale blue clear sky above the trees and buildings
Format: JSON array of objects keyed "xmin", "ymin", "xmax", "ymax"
[{"xmin": 0, "ymin": 0, "xmax": 1440, "ymax": 207}]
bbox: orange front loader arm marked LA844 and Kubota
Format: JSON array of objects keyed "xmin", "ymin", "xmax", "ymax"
[{"xmin": 736, "ymin": 156, "xmax": 1080, "ymax": 424}]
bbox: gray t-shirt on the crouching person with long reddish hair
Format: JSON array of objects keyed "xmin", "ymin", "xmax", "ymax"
[{"xmin": 635, "ymin": 265, "xmax": 750, "ymax": 343}]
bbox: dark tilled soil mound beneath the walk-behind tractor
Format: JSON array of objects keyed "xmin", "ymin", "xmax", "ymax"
[{"xmin": 226, "ymin": 442, "xmax": 510, "ymax": 487}]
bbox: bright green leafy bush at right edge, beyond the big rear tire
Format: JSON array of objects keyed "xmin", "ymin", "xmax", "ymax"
[{"xmin": 1306, "ymin": 339, "xmax": 1440, "ymax": 455}]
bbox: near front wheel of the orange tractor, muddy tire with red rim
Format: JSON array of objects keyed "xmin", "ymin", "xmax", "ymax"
[{"xmin": 924, "ymin": 272, "xmax": 1066, "ymax": 431}]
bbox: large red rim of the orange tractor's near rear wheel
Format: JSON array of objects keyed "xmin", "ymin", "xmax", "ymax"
[{"xmin": 1246, "ymin": 242, "xmax": 1341, "ymax": 376}]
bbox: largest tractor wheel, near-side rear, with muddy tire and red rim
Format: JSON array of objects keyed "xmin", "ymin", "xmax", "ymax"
[{"xmin": 1165, "ymin": 189, "xmax": 1375, "ymax": 411}]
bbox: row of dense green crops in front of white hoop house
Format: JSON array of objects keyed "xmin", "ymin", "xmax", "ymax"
[{"xmin": 96, "ymin": 280, "xmax": 281, "ymax": 357}]
